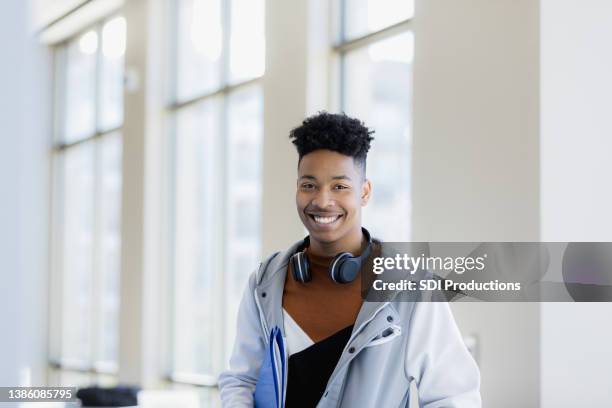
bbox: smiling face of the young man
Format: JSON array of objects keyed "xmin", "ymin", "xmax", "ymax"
[{"xmin": 295, "ymin": 150, "xmax": 371, "ymax": 252}]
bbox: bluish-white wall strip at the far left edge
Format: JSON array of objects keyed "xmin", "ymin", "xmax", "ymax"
[{"xmin": 0, "ymin": 1, "xmax": 50, "ymax": 386}]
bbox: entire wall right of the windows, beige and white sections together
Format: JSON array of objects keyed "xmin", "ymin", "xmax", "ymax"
[{"xmin": 413, "ymin": 0, "xmax": 612, "ymax": 408}]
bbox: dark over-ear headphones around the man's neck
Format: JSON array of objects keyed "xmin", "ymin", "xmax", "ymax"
[{"xmin": 289, "ymin": 227, "xmax": 372, "ymax": 283}]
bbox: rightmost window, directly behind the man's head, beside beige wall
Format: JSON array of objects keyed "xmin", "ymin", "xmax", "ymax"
[{"xmin": 334, "ymin": 0, "xmax": 414, "ymax": 241}]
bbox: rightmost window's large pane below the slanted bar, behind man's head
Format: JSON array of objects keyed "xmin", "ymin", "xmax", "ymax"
[{"xmin": 343, "ymin": 32, "xmax": 413, "ymax": 241}]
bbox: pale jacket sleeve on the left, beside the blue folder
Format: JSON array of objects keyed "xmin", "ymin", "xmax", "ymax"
[{"xmin": 219, "ymin": 273, "xmax": 265, "ymax": 408}]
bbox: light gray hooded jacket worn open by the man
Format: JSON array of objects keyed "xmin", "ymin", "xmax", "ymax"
[{"xmin": 219, "ymin": 243, "xmax": 481, "ymax": 408}]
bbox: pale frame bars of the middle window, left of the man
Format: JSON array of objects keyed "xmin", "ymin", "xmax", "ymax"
[{"xmin": 163, "ymin": 0, "xmax": 265, "ymax": 390}]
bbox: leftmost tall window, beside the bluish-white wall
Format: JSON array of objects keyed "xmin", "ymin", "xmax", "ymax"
[{"xmin": 50, "ymin": 16, "xmax": 126, "ymax": 385}]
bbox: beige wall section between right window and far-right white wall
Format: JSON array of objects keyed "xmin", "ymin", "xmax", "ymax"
[{"xmin": 412, "ymin": 0, "xmax": 540, "ymax": 408}]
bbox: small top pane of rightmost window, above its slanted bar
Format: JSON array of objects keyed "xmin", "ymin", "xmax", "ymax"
[{"xmin": 341, "ymin": 0, "xmax": 414, "ymax": 39}]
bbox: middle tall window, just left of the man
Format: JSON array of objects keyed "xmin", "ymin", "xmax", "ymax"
[{"xmin": 168, "ymin": 0, "xmax": 265, "ymax": 386}]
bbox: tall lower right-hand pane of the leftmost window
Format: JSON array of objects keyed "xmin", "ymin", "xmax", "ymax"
[{"xmin": 96, "ymin": 134, "xmax": 121, "ymax": 366}]
